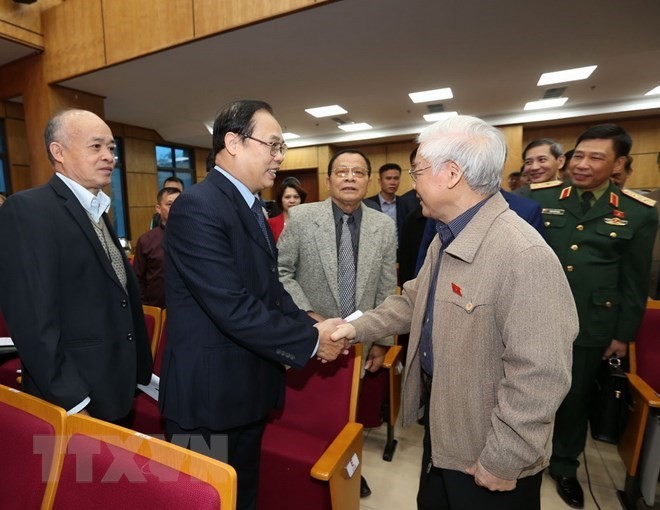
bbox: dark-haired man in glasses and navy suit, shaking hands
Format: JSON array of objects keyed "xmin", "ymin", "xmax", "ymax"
[{"xmin": 160, "ymin": 101, "xmax": 341, "ymax": 509}]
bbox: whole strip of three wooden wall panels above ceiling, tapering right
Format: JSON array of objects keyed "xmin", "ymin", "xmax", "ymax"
[{"xmin": 38, "ymin": 0, "xmax": 336, "ymax": 83}]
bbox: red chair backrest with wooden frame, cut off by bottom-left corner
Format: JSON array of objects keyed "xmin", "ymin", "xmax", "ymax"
[{"xmin": 0, "ymin": 386, "xmax": 66, "ymax": 509}]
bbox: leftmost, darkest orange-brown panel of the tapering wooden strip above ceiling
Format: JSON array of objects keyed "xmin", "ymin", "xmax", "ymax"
[{"xmin": 42, "ymin": 0, "xmax": 105, "ymax": 83}]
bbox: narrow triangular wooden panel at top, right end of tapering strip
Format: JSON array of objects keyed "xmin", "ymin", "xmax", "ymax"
[{"xmin": 193, "ymin": 0, "xmax": 336, "ymax": 37}]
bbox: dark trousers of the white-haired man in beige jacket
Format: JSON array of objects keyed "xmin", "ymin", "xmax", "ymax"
[{"xmin": 417, "ymin": 385, "xmax": 543, "ymax": 510}]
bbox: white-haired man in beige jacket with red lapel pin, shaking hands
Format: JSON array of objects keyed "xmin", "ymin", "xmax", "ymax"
[{"xmin": 333, "ymin": 116, "xmax": 578, "ymax": 510}]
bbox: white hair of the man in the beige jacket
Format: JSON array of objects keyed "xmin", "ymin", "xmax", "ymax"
[{"xmin": 417, "ymin": 115, "xmax": 506, "ymax": 195}]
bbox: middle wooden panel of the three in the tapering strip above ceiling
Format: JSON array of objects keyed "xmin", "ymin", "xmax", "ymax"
[{"xmin": 102, "ymin": 0, "xmax": 195, "ymax": 64}]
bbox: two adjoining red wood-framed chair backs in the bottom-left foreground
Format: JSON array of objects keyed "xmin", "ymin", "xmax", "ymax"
[{"xmin": 0, "ymin": 386, "xmax": 237, "ymax": 510}]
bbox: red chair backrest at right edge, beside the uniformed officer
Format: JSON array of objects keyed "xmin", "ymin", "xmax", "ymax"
[{"xmin": 633, "ymin": 299, "xmax": 660, "ymax": 393}]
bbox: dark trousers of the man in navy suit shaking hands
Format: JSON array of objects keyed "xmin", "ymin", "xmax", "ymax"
[{"xmin": 165, "ymin": 420, "xmax": 266, "ymax": 510}]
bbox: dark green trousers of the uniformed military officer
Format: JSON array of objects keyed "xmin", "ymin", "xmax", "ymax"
[{"xmin": 550, "ymin": 345, "xmax": 605, "ymax": 478}]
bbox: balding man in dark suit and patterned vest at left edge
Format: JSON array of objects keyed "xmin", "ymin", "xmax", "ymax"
[{"xmin": 0, "ymin": 110, "xmax": 151, "ymax": 421}]
